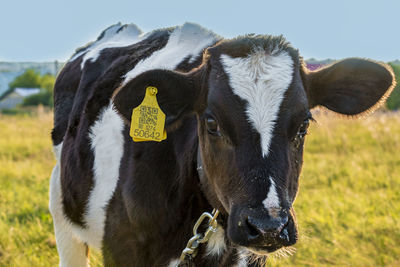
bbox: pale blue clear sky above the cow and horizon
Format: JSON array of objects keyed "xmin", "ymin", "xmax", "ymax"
[{"xmin": 0, "ymin": 0, "xmax": 400, "ymax": 61}]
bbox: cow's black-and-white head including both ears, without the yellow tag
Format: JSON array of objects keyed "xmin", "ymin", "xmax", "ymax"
[{"xmin": 114, "ymin": 36, "xmax": 394, "ymax": 255}]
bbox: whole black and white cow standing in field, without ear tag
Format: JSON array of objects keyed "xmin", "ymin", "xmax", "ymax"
[{"xmin": 50, "ymin": 23, "xmax": 394, "ymax": 267}]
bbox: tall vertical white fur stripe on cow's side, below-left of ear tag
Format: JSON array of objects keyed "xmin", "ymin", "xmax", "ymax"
[{"xmin": 73, "ymin": 103, "xmax": 124, "ymax": 248}]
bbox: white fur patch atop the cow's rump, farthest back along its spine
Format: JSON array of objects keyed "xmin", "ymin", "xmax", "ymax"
[{"xmin": 69, "ymin": 23, "xmax": 145, "ymax": 69}]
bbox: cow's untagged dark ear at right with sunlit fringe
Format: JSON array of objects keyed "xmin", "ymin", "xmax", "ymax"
[{"xmin": 305, "ymin": 58, "xmax": 396, "ymax": 115}]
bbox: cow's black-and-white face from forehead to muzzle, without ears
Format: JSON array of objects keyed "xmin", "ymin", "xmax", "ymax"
[{"xmin": 198, "ymin": 40, "xmax": 311, "ymax": 252}]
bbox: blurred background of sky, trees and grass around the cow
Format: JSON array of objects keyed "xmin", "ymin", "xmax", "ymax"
[{"xmin": 0, "ymin": 0, "xmax": 400, "ymax": 266}]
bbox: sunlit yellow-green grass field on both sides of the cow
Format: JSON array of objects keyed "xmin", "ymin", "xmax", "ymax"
[{"xmin": 0, "ymin": 112, "xmax": 400, "ymax": 266}]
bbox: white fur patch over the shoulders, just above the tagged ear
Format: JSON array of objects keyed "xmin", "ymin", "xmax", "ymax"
[{"xmin": 123, "ymin": 23, "xmax": 219, "ymax": 85}]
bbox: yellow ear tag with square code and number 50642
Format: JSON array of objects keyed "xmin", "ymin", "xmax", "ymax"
[{"xmin": 130, "ymin": 86, "xmax": 167, "ymax": 142}]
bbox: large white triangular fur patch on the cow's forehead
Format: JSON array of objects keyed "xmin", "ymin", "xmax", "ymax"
[{"xmin": 221, "ymin": 49, "xmax": 293, "ymax": 157}]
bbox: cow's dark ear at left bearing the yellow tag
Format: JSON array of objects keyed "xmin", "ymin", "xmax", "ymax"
[{"xmin": 113, "ymin": 69, "xmax": 198, "ymax": 127}]
